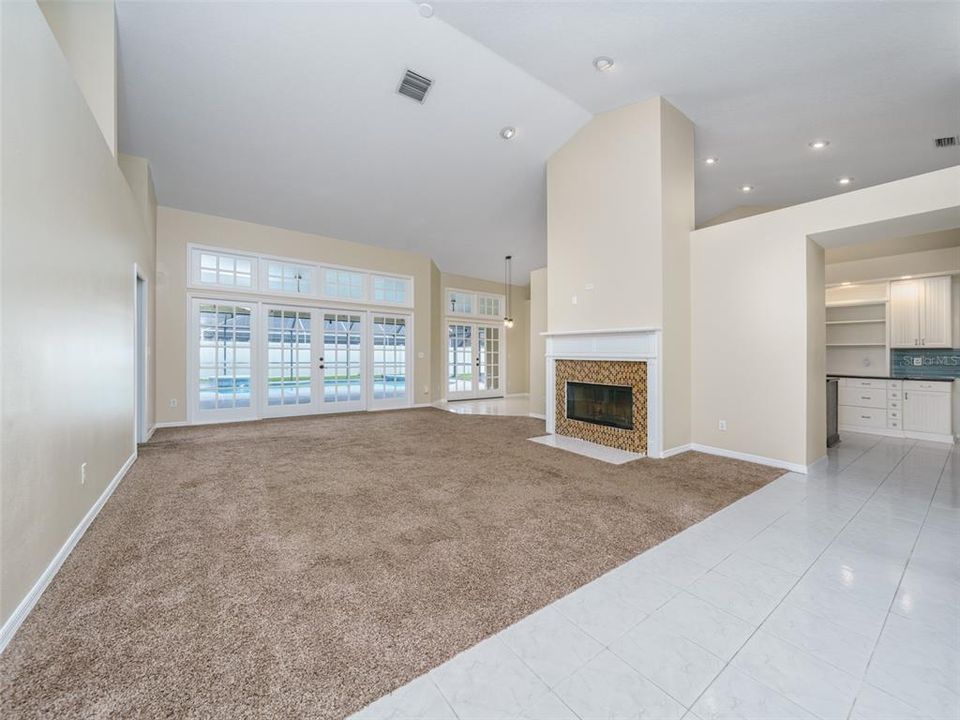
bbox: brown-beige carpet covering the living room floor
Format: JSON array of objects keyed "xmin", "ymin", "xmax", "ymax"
[{"xmin": 0, "ymin": 409, "xmax": 781, "ymax": 718}]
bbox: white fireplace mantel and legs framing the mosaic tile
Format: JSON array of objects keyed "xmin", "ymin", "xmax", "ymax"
[{"xmin": 541, "ymin": 328, "xmax": 663, "ymax": 458}]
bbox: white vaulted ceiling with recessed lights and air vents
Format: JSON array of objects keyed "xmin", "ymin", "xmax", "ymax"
[{"xmin": 118, "ymin": 0, "xmax": 960, "ymax": 282}]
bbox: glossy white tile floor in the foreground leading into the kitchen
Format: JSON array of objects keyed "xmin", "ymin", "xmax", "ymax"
[{"xmin": 354, "ymin": 434, "xmax": 960, "ymax": 720}]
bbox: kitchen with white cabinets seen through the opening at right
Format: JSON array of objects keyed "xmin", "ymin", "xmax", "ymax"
[{"xmin": 826, "ymin": 229, "xmax": 960, "ymax": 445}]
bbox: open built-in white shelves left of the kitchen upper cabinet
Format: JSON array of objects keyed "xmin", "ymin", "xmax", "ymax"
[{"xmin": 826, "ymin": 286, "xmax": 890, "ymax": 375}]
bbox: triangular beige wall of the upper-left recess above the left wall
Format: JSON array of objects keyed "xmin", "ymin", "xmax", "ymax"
[{"xmin": 39, "ymin": 0, "xmax": 117, "ymax": 155}]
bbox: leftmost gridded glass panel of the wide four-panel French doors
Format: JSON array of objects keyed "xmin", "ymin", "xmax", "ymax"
[{"xmin": 193, "ymin": 300, "xmax": 256, "ymax": 420}]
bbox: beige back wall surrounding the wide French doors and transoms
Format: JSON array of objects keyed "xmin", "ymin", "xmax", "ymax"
[{"xmin": 156, "ymin": 206, "xmax": 442, "ymax": 422}]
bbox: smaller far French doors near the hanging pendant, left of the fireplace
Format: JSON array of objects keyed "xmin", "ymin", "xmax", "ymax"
[{"xmin": 447, "ymin": 322, "xmax": 504, "ymax": 400}]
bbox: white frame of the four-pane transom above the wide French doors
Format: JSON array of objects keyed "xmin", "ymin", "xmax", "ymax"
[{"xmin": 187, "ymin": 243, "xmax": 416, "ymax": 309}]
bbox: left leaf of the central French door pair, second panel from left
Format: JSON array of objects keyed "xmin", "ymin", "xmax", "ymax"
[{"xmin": 263, "ymin": 305, "xmax": 319, "ymax": 417}]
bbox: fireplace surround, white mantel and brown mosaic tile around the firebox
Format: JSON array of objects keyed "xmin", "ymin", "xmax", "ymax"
[{"xmin": 543, "ymin": 328, "xmax": 663, "ymax": 458}]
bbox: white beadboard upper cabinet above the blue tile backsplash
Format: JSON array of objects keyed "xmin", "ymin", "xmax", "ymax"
[{"xmin": 890, "ymin": 276, "xmax": 952, "ymax": 348}]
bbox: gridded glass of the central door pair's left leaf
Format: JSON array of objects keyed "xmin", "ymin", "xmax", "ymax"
[{"xmin": 267, "ymin": 310, "xmax": 313, "ymax": 406}]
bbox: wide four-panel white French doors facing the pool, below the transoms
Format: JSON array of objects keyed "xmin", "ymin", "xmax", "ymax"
[{"xmin": 190, "ymin": 299, "xmax": 413, "ymax": 422}]
